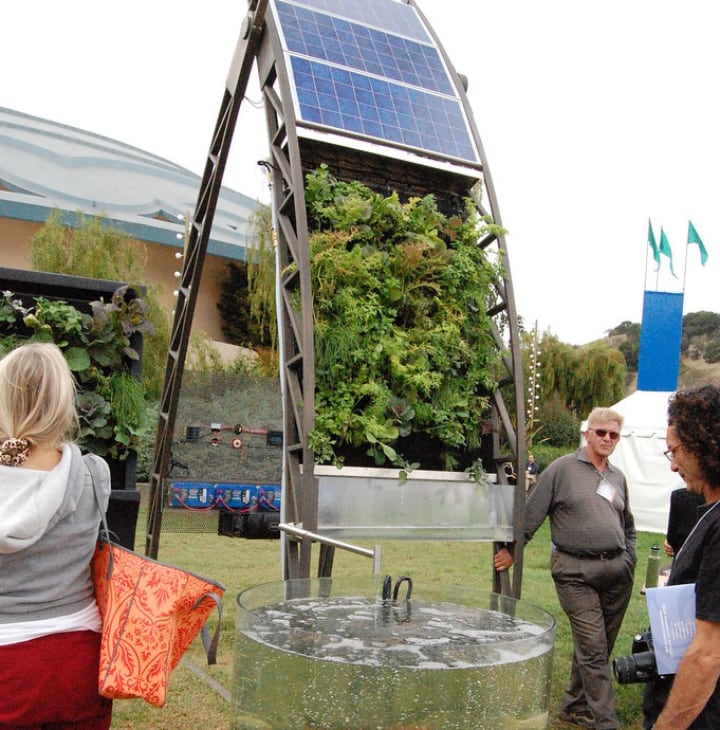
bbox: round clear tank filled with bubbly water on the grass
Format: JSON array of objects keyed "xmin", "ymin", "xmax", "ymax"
[{"xmin": 232, "ymin": 578, "xmax": 555, "ymax": 730}]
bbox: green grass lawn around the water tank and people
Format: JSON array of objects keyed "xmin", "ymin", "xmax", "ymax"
[{"xmin": 112, "ymin": 506, "xmax": 662, "ymax": 730}]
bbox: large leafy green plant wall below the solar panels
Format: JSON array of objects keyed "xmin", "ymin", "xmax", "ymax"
[{"xmin": 305, "ymin": 166, "xmax": 502, "ymax": 470}]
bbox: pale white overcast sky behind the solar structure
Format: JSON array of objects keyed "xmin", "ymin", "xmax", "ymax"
[{"xmin": 0, "ymin": 0, "xmax": 720, "ymax": 344}]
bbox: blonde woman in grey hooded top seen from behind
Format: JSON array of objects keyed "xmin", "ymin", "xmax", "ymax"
[{"xmin": 0, "ymin": 343, "xmax": 112, "ymax": 730}]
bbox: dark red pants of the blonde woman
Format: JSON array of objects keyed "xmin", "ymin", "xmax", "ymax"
[{"xmin": 0, "ymin": 631, "xmax": 112, "ymax": 730}]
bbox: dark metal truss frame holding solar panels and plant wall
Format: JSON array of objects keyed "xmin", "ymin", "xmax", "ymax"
[{"xmin": 146, "ymin": 0, "xmax": 527, "ymax": 597}]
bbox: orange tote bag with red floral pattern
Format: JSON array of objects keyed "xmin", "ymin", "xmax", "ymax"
[{"xmin": 88, "ymin": 464, "xmax": 225, "ymax": 707}]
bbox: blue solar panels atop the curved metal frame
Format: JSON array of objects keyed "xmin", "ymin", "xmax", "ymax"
[{"xmin": 274, "ymin": 0, "xmax": 479, "ymax": 163}]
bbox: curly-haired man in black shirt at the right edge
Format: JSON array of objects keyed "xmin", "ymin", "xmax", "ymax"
[{"xmin": 643, "ymin": 385, "xmax": 720, "ymax": 730}]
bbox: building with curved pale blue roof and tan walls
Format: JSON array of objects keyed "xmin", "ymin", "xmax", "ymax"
[{"xmin": 0, "ymin": 107, "xmax": 258, "ymax": 340}]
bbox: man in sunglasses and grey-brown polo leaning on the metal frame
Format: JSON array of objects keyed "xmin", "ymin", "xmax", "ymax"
[{"xmin": 495, "ymin": 408, "xmax": 637, "ymax": 730}]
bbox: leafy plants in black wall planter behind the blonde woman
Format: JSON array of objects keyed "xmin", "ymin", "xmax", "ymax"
[{"xmin": 0, "ymin": 286, "xmax": 151, "ymax": 461}]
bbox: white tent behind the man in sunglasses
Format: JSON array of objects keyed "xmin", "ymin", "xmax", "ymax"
[{"xmin": 610, "ymin": 390, "xmax": 685, "ymax": 534}]
